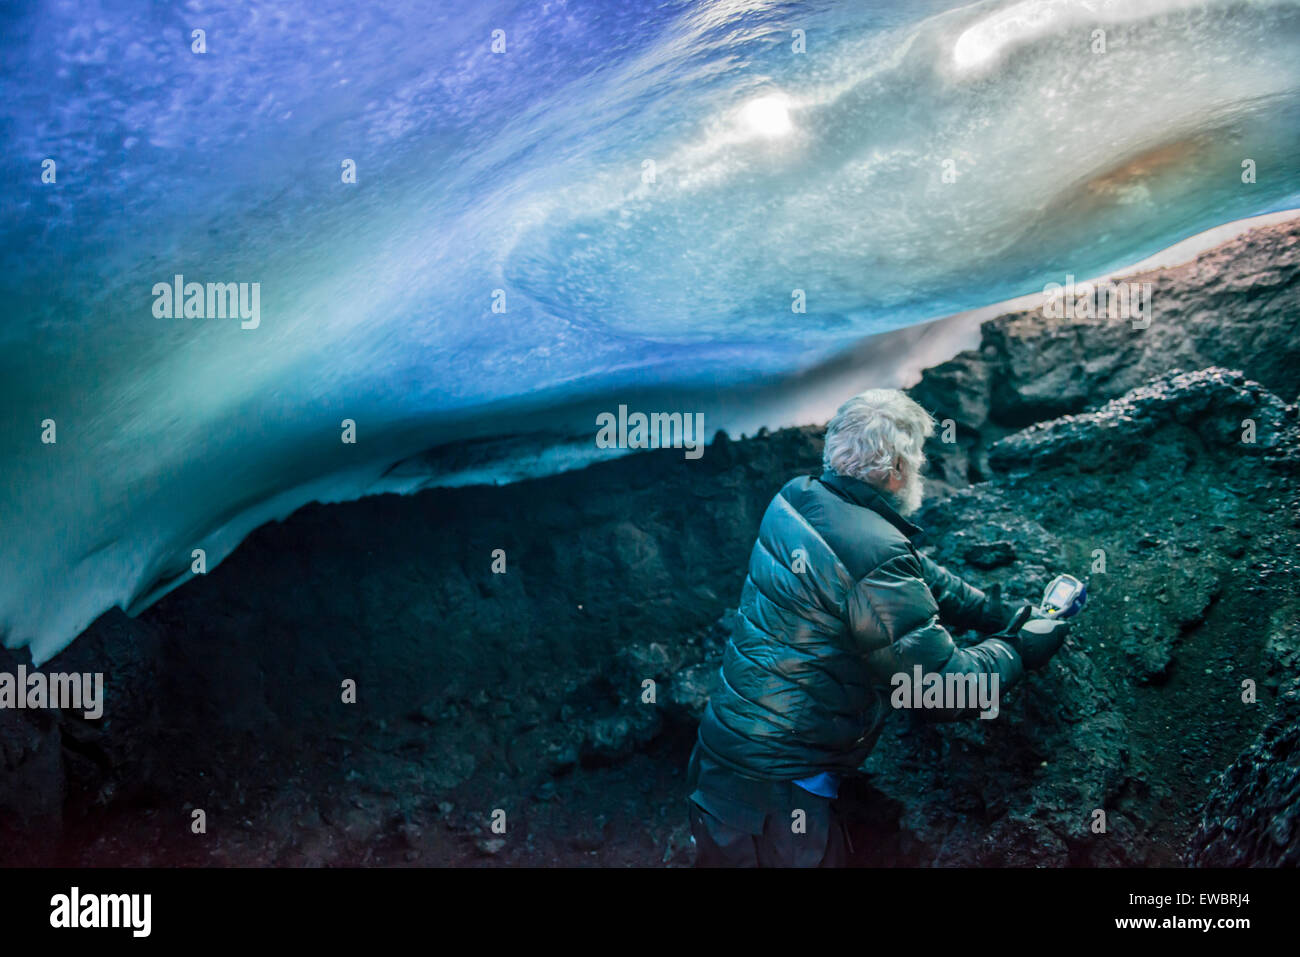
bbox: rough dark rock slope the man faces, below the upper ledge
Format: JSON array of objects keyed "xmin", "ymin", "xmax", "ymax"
[{"xmin": 862, "ymin": 369, "xmax": 1300, "ymax": 866}]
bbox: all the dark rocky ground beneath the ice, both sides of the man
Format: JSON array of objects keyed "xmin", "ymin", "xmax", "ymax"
[{"xmin": 0, "ymin": 217, "xmax": 1300, "ymax": 866}]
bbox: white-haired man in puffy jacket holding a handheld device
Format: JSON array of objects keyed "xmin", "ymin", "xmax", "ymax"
[{"xmin": 688, "ymin": 389, "xmax": 1067, "ymax": 867}]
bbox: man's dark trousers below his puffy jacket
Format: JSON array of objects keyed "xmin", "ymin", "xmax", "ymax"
[{"xmin": 688, "ymin": 749, "xmax": 852, "ymax": 867}]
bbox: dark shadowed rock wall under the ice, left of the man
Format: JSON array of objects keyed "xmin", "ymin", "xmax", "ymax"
[{"xmin": 0, "ymin": 418, "xmax": 822, "ymax": 866}]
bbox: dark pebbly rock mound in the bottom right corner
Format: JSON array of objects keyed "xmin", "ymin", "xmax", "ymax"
[{"xmin": 1190, "ymin": 683, "xmax": 1300, "ymax": 867}]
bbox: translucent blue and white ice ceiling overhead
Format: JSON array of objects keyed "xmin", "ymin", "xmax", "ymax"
[{"xmin": 0, "ymin": 0, "xmax": 1300, "ymax": 661}]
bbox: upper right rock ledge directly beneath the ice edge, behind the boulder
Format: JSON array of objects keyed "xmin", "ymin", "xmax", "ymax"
[{"xmin": 910, "ymin": 220, "xmax": 1300, "ymax": 488}]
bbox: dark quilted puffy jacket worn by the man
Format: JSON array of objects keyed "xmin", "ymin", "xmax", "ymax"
[{"xmin": 699, "ymin": 471, "xmax": 1023, "ymax": 780}]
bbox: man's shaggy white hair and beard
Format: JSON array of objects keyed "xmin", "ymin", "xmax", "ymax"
[{"xmin": 822, "ymin": 389, "xmax": 935, "ymax": 485}]
